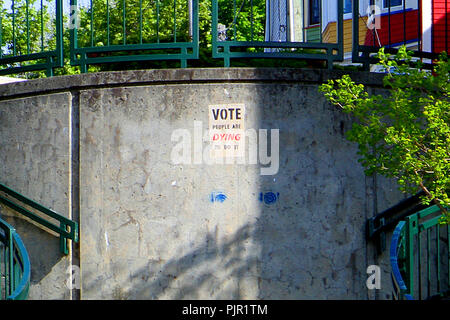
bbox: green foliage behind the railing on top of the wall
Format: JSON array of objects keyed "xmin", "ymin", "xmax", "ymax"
[{"xmin": 1, "ymin": 0, "xmax": 306, "ymax": 74}]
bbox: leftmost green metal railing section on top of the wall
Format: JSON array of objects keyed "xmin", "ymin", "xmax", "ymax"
[{"xmin": 0, "ymin": 0, "xmax": 63, "ymax": 76}]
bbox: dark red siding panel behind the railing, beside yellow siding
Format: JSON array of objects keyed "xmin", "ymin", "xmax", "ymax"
[{"xmin": 364, "ymin": 10, "xmax": 420, "ymax": 47}]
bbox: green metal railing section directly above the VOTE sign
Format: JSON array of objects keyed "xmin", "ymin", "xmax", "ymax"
[{"xmin": 212, "ymin": 0, "xmax": 344, "ymax": 68}]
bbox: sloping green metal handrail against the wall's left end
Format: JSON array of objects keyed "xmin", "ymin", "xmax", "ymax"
[{"xmin": 0, "ymin": 183, "xmax": 78, "ymax": 254}]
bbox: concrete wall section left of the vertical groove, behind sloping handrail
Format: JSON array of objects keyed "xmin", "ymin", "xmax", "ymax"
[{"xmin": 0, "ymin": 92, "xmax": 72, "ymax": 299}]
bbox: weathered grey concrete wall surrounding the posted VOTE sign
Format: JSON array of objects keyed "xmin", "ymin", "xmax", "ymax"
[{"xmin": 0, "ymin": 69, "xmax": 403, "ymax": 299}]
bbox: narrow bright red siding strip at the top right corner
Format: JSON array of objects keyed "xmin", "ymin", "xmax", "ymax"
[{"xmin": 433, "ymin": 0, "xmax": 450, "ymax": 53}]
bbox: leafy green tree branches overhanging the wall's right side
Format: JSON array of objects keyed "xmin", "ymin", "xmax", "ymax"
[{"xmin": 319, "ymin": 47, "xmax": 450, "ymax": 223}]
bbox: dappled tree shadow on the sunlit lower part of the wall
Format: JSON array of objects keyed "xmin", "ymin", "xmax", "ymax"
[{"xmin": 83, "ymin": 225, "xmax": 257, "ymax": 300}]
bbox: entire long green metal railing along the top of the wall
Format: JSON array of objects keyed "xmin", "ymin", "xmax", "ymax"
[{"xmin": 0, "ymin": 0, "xmax": 449, "ymax": 76}]
